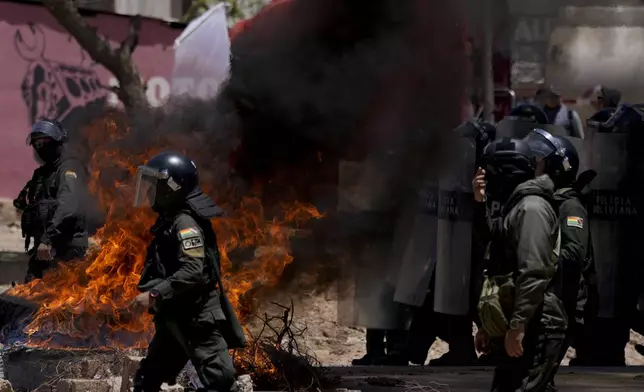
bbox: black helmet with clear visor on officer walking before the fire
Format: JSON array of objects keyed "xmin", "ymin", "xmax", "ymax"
[{"xmin": 134, "ymin": 152, "xmax": 199, "ymax": 212}]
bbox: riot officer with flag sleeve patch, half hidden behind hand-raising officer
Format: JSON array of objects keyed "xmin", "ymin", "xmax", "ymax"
[{"xmin": 527, "ymin": 129, "xmax": 596, "ymax": 389}]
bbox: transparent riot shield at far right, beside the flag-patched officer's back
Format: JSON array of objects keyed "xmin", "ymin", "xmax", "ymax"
[{"xmin": 584, "ymin": 128, "xmax": 636, "ymax": 318}]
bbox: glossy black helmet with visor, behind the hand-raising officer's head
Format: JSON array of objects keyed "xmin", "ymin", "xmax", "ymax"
[{"xmin": 524, "ymin": 129, "xmax": 579, "ymax": 188}]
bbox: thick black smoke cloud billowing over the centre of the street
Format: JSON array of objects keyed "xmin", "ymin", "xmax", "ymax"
[{"xmin": 79, "ymin": 0, "xmax": 469, "ymax": 288}]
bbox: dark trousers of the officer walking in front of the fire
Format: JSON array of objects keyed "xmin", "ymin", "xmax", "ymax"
[{"xmin": 133, "ymin": 322, "xmax": 236, "ymax": 392}]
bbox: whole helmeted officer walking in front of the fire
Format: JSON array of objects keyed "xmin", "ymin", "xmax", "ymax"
[{"xmin": 133, "ymin": 153, "xmax": 246, "ymax": 392}]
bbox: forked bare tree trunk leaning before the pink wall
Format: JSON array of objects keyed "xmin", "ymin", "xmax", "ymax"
[{"xmin": 43, "ymin": 0, "xmax": 149, "ymax": 112}]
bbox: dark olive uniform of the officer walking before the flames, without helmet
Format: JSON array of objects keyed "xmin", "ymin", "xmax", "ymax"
[{"xmin": 134, "ymin": 211, "xmax": 243, "ymax": 392}]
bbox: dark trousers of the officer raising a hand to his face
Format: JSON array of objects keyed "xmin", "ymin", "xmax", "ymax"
[{"xmin": 491, "ymin": 330, "xmax": 564, "ymax": 392}]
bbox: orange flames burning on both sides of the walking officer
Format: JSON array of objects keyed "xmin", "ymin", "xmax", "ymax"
[{"xmin": 6, "ymin": 112, "xmax": 321, "ymax": 374}]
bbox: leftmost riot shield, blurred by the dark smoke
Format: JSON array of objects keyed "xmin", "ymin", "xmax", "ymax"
[{"xmin": 336, "ymin": 159, "xmax": 404, "ymax": 329}]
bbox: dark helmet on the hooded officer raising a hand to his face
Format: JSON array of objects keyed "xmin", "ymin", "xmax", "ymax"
[{"xmin": 480, "ymin": 138, "xmax": 536, "ymax": 203}]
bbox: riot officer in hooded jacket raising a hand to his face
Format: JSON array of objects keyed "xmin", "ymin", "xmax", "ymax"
[{"xmin": 473, "ymin": 138, "xmax": 566, "ymax": 392}]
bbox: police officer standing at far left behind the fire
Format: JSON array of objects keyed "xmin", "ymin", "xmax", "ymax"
[{"xmin": 13, "ymin": 120, "xmax": 88, "ymax": 283}]
